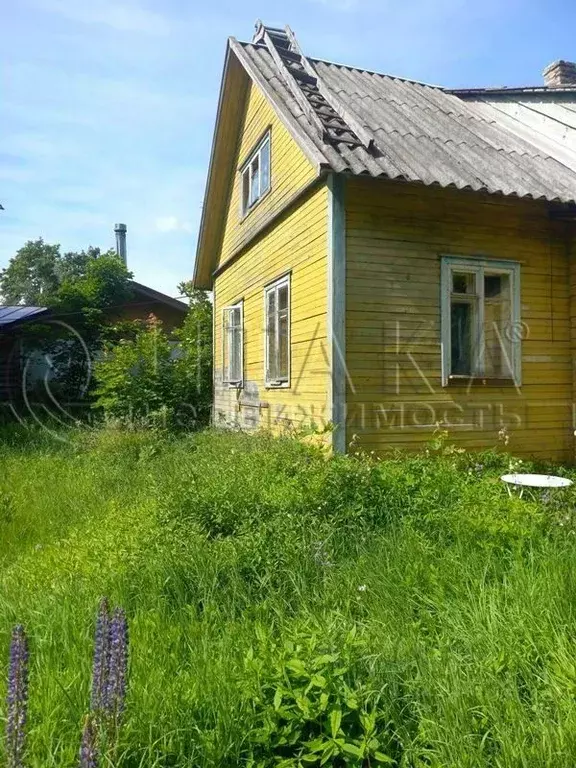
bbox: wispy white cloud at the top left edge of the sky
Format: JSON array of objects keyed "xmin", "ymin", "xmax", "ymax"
[{"xmin": 31, "ymin": 0, "xmax": 170, "ymax": 35}]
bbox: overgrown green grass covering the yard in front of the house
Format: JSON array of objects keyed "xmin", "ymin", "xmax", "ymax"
[{"xmin": 0, "ymin": 430, "xmax": 576, "ymax": 768}]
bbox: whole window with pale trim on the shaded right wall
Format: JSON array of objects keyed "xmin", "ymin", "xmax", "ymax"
[{"xmin": 441, "ymin": 256, "xmax": 522, "ymax": 386}]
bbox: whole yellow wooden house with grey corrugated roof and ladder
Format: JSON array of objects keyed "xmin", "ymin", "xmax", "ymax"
[{"xmin": 194, "ymin": 23, "xmax": 576, "ymax": 460}]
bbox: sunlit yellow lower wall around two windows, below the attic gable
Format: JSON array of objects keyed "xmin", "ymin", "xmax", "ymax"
[{"xmin": 214, "ymin": 185, "xmax": 330, "ymax": 428}]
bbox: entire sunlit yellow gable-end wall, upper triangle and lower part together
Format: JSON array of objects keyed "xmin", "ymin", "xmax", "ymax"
[{"xmin": 214, "ymin": 85, "xmax": 330, "ymax": 436}]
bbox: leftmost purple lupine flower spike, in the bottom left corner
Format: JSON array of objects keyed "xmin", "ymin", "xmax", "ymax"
[{"xmin": 6, "ymin": 624, "xmax": 29, "ymax": 768}]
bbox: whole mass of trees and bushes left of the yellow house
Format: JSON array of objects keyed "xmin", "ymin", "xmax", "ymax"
[{"xmin": 0, "ymin": 238, "xmax": 212, "ymax": 428}]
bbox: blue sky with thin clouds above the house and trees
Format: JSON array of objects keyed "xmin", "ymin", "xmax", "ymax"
[{"xmin": 0, "ymin": 0, "xmax": 576, "ymax": 296}]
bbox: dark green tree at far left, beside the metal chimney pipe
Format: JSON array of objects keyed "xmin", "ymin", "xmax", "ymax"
[{"xmin": 0, "ymin": 238, "xmax": 135, "ymax": 402}]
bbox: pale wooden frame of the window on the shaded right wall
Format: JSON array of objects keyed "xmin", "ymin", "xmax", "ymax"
[{"xmin": 440, "ymin": 256, "xmax": 523, "ymax": 387}]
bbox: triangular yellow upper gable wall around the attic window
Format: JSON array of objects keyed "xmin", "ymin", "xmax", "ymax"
[{"xmin": 218, "ymin": 83, "xmax": 317, "ymax": 265}]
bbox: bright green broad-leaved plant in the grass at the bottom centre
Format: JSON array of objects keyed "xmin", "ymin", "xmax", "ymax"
[{"xmin": 246, "ymin": 629, "xmax": 396, "ymax": 768}]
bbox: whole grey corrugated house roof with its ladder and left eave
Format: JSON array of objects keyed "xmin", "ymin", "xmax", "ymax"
[{"xmin": 194, "ymin": 23, "xmax": 576, "ymax": 287}]
